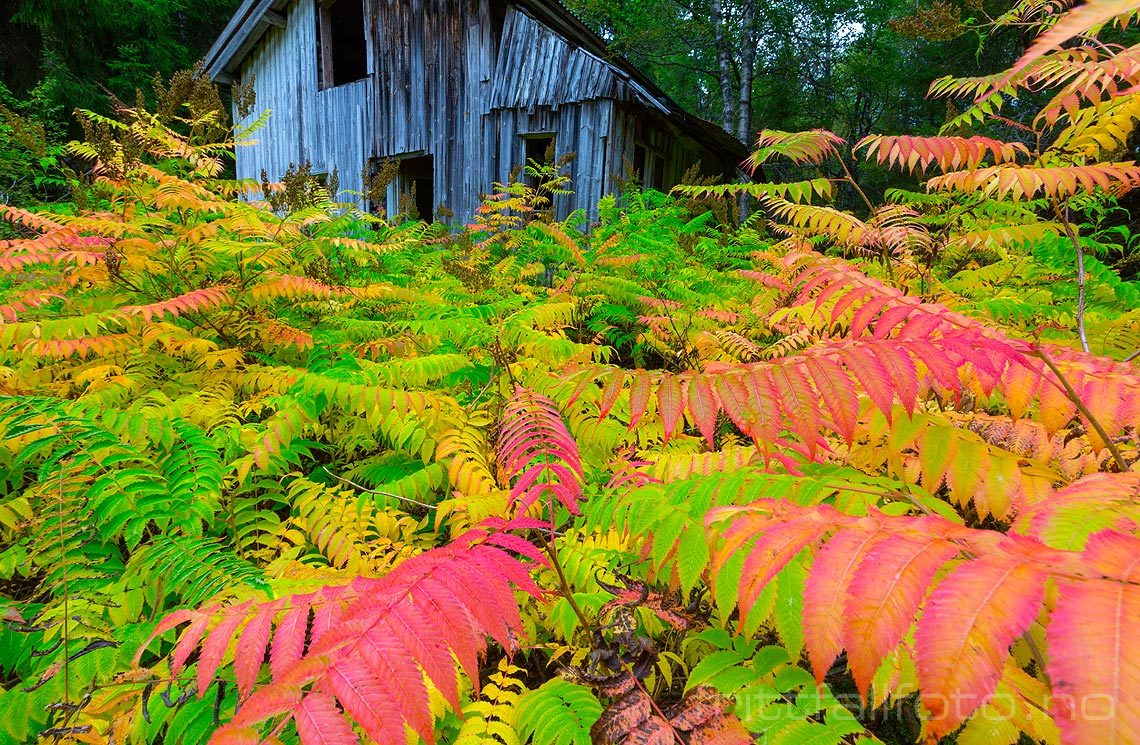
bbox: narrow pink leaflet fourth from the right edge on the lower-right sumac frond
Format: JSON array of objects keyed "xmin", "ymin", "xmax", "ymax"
[{"xmin": 804, "ymin": 530, "xmax": 886, "ymax": 682}]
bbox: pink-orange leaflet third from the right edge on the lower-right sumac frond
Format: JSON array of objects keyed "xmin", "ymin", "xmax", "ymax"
[{"xmin": 844, "ymin": 535, "xmax": 960, "ymax": 697}]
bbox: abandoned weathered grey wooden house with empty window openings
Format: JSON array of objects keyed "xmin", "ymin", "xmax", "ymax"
[{"xmin": 206, "ymin": 0, "xmax": 744, "ymax": 220}]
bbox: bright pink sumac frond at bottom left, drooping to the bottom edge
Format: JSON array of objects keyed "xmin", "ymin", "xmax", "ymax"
[{"xmin": 141, "ymin": 533, "xmax": 538, "ymax": 743}]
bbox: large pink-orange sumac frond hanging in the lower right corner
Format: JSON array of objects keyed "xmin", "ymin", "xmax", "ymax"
[{"xmin": 709, "ymin": 500, "xmax": 1140, "ymax": 742}]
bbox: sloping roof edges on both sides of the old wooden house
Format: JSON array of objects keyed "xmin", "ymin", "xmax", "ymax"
[{"xmin": 205, "ymin": 0, "xmax": 747, "ymax": 158}]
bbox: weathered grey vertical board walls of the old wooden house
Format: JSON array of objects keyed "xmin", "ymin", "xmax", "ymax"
[{"xmin": 232, "ymin": 0, "xmax": 734, "ymax": 220}]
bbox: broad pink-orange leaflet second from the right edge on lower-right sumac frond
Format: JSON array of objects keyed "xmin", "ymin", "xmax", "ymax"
[{"xmin": 914, "ymin": 557, "xmax": 1045, "ymax": 737}]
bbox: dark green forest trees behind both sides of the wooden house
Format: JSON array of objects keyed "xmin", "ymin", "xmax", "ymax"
[{"xmin": 0, "ymin": 0, "xmax": 1032, "ymax": 207}]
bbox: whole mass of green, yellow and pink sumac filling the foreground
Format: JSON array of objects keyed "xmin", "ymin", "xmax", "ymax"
[{"xmin": 0, "ymin": 8, "xmax": 1140, "ymax": 745}]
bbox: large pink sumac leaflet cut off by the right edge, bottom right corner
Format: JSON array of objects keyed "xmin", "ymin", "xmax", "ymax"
[{"xmin": 1045, "ymin": 531, "xmax": 1140, "ymax": 745}]
